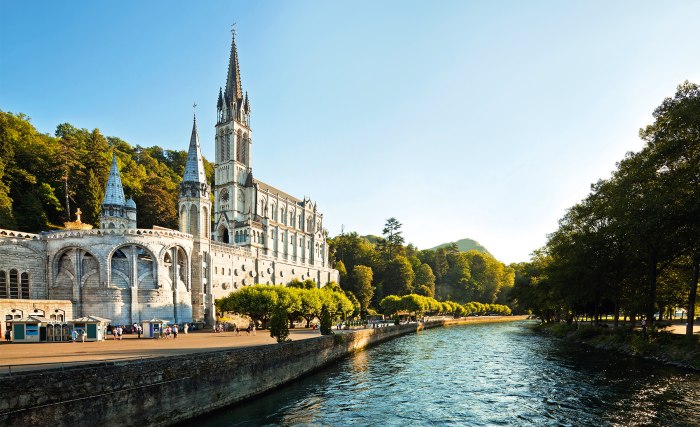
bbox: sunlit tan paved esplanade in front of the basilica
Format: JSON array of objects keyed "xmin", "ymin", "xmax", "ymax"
[{"xmin": 0, "ymin": 329, "xmax": 320, "ymax": 375}]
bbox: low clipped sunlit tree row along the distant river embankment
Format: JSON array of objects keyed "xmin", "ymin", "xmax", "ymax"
[{"xmin": 379, "ymin": 294, "xmax": 511, "ymax": 317}]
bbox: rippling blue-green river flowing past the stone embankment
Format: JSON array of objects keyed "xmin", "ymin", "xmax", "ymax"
[{"xmin": 194, "ymin": 322, "xmax": 700, "ymax": 426}]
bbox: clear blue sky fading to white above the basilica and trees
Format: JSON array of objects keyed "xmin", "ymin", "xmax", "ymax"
[{"xmin": 0, "ymin": 0, "xmax": 700, "ymax": 262}]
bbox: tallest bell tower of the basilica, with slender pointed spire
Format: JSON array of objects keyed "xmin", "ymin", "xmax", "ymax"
[{"xmin": 212, "ymin": 29, "xmax": 254, "ymax": 243}]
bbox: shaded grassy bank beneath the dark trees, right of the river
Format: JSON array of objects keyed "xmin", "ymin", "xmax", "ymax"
[{"xmin": 536, "ymin": 323, "xmax": 700, "ymax": 371}]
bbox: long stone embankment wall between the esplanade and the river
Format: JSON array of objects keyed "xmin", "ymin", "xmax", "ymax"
[{"xmin": 0, "ymin": 318, "xmax": 515, "ymax": 427}]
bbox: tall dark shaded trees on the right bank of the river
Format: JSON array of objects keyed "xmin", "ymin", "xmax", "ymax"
[{"xmin": 513, "ymin": 81, "xmax": 700, "ymax": 335}]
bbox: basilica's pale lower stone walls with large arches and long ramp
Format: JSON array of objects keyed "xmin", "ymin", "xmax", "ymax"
[{"xmin": 0, "ymin": 224, "xmax": 338, "ymax": 325}]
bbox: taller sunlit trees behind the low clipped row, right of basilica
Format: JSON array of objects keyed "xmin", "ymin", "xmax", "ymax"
[{"xmin": 329, "ymin": 218, "xmax": 514, "ymax": 311}]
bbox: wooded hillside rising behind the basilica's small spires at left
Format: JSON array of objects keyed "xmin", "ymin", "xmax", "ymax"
[{"xmin": 0, "ymin": 111, "xmax": 213, "ymax": 232}]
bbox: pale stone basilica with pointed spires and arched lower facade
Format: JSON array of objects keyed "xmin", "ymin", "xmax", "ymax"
[{"xmin": 0, "ymin": 30, "xmax": 338, "ymax": 329}]
